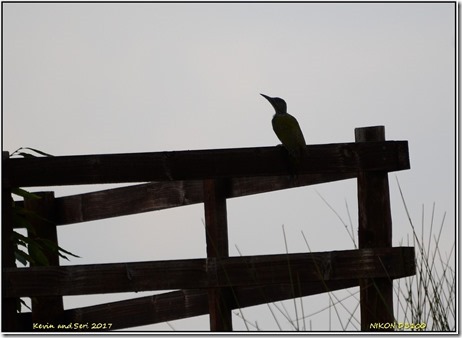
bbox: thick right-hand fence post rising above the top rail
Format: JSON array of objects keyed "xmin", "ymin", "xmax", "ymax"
[{"xmin": 355, "ymin": 126, "xmax": 394, "ymax": 331}]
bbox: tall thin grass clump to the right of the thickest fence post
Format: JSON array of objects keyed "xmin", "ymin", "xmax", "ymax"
[{"xmin": 395, "ymin": 181, "xmax": 456, "ymax": 331}]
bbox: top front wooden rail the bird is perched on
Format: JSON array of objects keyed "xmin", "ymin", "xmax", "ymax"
[{"xmin": 3, "ymin": 141, "xmax": 409, "ymax": 187}]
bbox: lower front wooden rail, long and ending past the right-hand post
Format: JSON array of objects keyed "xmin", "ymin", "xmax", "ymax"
[{"xmin": 2, "ymin": 247, "xmax": 415, "ymax": 297}]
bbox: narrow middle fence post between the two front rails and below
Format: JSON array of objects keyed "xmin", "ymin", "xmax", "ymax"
[{"xmin": 203, "ymin": 179, "xmax": 233, "ymax": 331}]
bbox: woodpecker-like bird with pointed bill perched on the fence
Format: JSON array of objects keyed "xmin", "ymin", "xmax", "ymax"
[{"xmin": 260, "ymin": 94, "xmax": 306, "ymax": 170}]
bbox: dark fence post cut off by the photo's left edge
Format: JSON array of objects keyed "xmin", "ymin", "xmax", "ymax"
[{"xmin": 2, "ymin": 151, "xmax": 18, "ymax": 332}]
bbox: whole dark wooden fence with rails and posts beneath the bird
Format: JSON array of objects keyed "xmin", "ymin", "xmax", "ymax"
[{"xmin": 2, "ymin": 127, "xmax": 415, "ymax": 332}]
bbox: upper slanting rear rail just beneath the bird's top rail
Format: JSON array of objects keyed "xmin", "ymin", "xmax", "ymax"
[{"xmin": 12, "ymin": 173, "xmax": 356, "ymax": 225}]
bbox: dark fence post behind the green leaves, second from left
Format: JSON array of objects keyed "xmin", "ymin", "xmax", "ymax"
[{"xmin": 24, "ymin": 191, "xmax": 64, "ymax": 330}]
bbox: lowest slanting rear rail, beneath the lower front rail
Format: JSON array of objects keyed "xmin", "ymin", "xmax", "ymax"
[{"xmin": 21, "ymin": 279, "xmax": 359, "ymax": 332}]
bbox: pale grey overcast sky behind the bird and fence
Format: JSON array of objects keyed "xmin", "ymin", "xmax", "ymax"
[{"xmin": 3, "ymin": 3, "xmax": 455, "ymax": 330}]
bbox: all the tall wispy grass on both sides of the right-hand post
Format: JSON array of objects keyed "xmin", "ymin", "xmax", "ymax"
[{"xmin": 234, "ymin": 180, "xmax": 456, "ymax": 332}]
